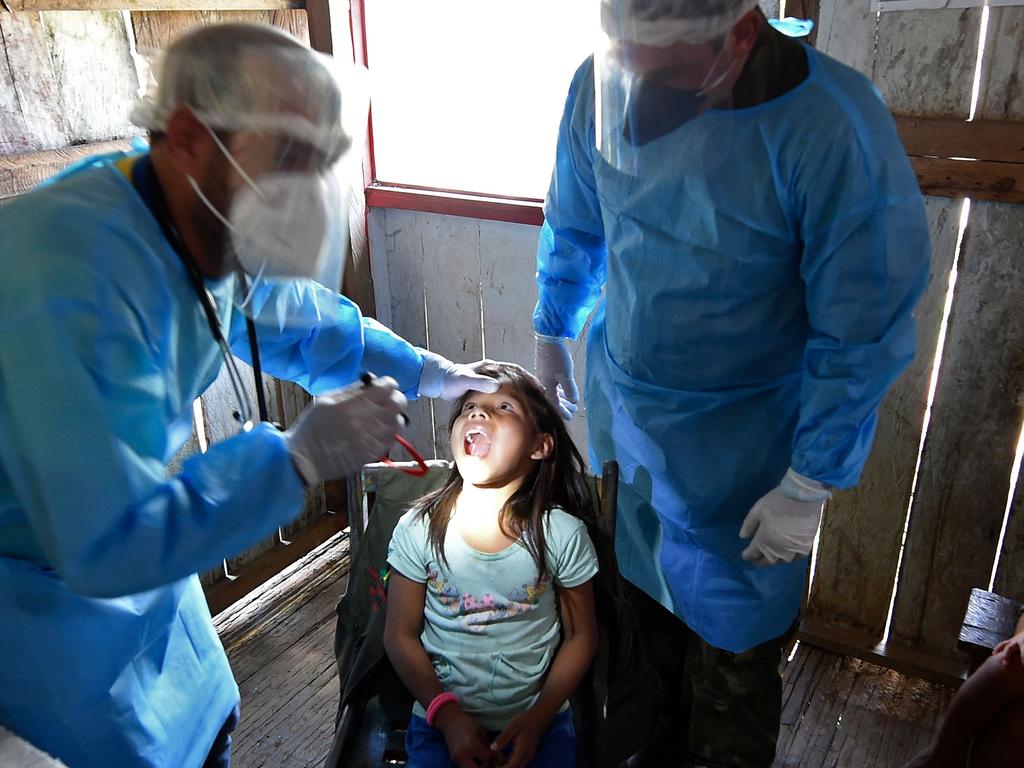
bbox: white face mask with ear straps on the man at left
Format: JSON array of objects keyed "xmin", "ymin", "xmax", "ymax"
[{"xmin": 188, "ymin": 123, "xmax": 335, "ymax": 280}]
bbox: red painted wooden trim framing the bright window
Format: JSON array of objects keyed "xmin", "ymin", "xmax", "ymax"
[{"xmin": 349, "ymin": 0, "xmax": 544, "ymax": 226}]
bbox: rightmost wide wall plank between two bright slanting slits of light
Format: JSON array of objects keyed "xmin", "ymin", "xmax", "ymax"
[{"xmin": 893, "ymin": 7, "xmax": 1024, "ymax": 653}]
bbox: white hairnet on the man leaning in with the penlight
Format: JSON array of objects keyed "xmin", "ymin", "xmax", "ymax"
[{"xmin": 131, "ymin": 24, "xmax": 366, "ymax": 158}]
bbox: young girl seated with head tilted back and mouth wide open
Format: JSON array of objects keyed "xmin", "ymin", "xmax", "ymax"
[{"xmin": 384, "ymin": 362, "xmax": 597, "ymax": 768}]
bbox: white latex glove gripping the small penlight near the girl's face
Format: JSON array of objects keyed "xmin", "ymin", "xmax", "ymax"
[{"xmin": 285, "ymin": 378, "xmax": 409, "ymax": 485}]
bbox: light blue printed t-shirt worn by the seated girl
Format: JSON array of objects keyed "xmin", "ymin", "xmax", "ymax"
[{"xmin": 388, "ymin": 509, "xmax": 597, "ymax": 731}]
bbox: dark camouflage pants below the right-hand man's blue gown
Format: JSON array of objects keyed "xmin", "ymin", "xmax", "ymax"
[{"xmin": 628, "ymin": 585, "xmax": 796, "ymax": 768}]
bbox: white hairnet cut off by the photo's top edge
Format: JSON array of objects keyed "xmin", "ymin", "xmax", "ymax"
[{"xmin": 601, "ymin": 0, "xmax": 758, "ymax": 46}]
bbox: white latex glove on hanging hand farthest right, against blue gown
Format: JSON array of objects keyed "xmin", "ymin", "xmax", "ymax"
[{"xmin": 739, "ymin": 469, "xmax": 831, "ymax": 565}]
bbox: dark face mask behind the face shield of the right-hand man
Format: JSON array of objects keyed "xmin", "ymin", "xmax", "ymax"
[{"xmin": 623, "ymin": 46, "xmax": 732, "ymax": 146}]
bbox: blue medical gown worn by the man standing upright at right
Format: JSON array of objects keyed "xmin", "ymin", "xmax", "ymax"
[{"xmin": 534, "ymin": 48, "xmax": 930, "ymax": 651}]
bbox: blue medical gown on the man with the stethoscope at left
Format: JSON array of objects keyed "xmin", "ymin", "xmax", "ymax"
[{"xmin": 0, "ymin": 158, "xmax": 422, "ymax": 768}]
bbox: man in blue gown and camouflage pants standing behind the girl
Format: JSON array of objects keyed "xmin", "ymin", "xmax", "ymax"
[{"xmin": 534, "ymin": 0, "xmax": 930, "ymax": 767}]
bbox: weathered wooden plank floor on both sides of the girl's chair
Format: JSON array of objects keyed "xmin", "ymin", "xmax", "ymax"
[{"xmin": 214, "ymin": 535, "xmax": 952, "ymax": 768}]
